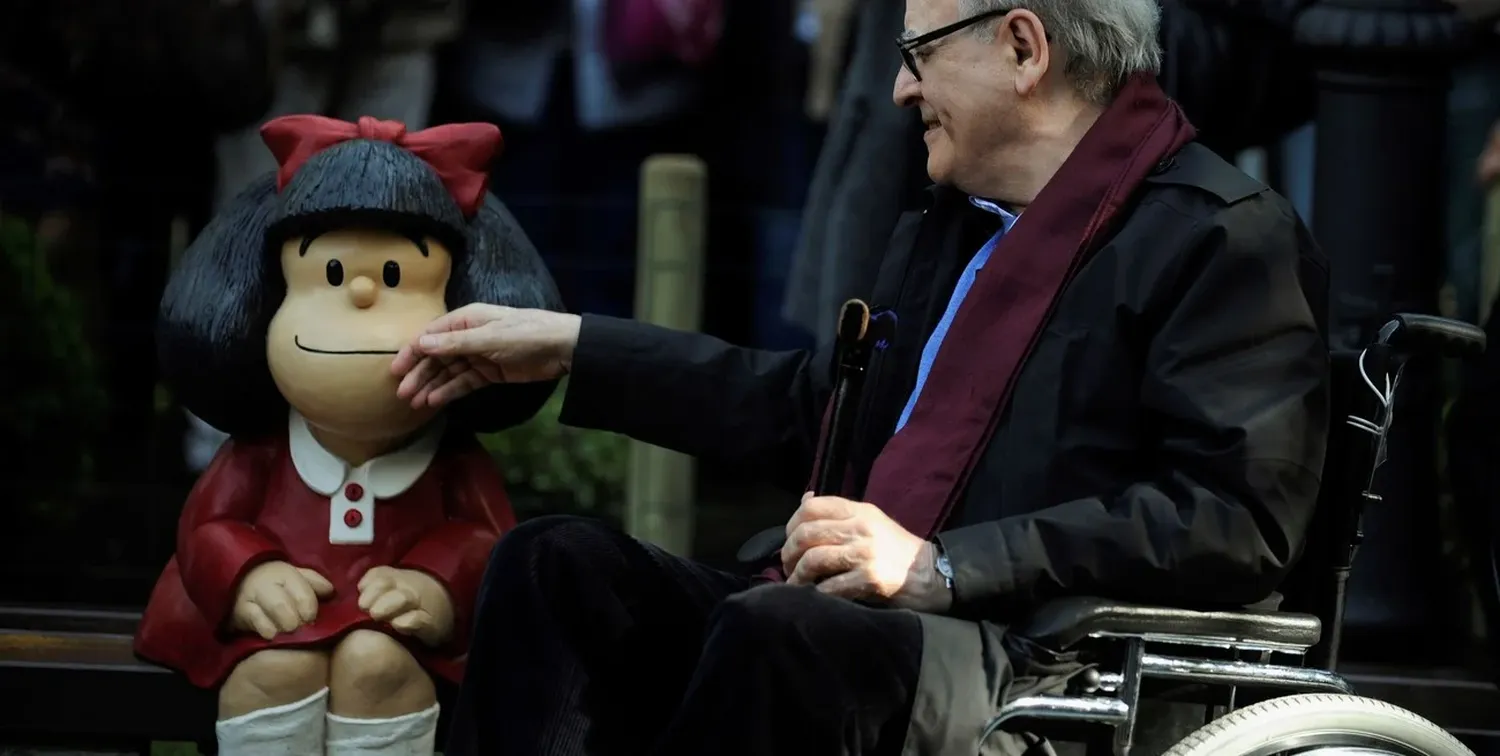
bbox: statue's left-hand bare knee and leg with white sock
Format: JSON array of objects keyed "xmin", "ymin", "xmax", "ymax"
[{"xmin": 216, "ymin": 650, "xmax": 329, "ymax": 756}]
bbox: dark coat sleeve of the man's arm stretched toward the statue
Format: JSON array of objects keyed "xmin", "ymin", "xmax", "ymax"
[{"xmin": 561, "ymin": 315, "xmax": 833, "ymax": 491}]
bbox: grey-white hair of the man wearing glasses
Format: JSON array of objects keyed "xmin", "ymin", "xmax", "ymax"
[{"xmin": 959, "ymin": 0, "xmax": 1161, "ymax": 104}]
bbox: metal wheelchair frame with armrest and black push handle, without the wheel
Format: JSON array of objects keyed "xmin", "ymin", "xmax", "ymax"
[{"xmin": 980, "ymin": 314, "xmax": 1485, "ymax": 756}]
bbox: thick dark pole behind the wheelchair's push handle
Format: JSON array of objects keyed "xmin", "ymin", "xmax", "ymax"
[{"xmin": 1296, "ymin": 0, "xmax": 1464, "ymax": 662}]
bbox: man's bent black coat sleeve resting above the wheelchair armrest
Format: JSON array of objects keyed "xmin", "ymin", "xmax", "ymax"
[{"xmin": 939, "ymin": 200, "xmax": 1329, "ymax": 617}]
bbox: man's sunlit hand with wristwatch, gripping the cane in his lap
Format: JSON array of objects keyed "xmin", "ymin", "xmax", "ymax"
[{"xmin": 782, "ymin": 494, "xmax": 953, "ymax": 612}]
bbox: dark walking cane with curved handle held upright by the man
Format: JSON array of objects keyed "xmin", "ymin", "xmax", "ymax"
[{"xmin": 738, "ymin": 299, "xmax": 875, "ymax": 566}]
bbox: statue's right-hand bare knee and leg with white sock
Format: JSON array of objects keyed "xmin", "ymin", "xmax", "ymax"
[{"xmin": 327, "ymin": 630, "xmax": 438, "ymax": 756}]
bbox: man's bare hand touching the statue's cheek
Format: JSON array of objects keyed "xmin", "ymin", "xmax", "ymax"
[{"xmin": 390, "ymin": 305, "xmax": 581, "ymax": 410}]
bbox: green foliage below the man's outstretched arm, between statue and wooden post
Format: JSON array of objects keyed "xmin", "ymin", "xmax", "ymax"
[{"xmin": 480, "ymin": 381, "xmax": 630, "ymax": 516}]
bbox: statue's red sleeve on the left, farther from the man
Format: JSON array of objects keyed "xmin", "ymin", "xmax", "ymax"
[{"xmin": 177, "ymin": 440, "xmax": 287, "ymax": 627}]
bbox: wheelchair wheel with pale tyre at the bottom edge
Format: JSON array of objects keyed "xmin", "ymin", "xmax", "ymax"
[{"xmin": 1163, "ymin": 693, "xmax": 1475, "ymax": 756}]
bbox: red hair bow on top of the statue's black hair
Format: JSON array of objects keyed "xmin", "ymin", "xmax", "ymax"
[{"xmin": 261, "ymin": 116, "xmax": 501, "ymax": 218}]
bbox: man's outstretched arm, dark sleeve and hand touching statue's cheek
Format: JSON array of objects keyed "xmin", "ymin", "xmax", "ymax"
[{"xmin": 392, "ymin": 305, "xmax": 833, "ymax": 491}]
